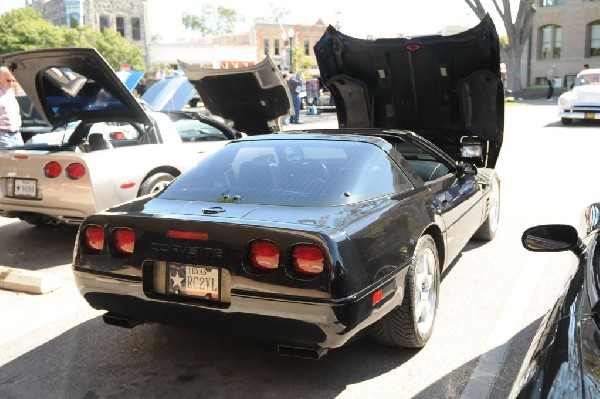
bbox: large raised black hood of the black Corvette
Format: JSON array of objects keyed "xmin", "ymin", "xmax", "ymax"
[{"xmin": 314, "ymin": 15, "xmax": 504, "ymax": 167}]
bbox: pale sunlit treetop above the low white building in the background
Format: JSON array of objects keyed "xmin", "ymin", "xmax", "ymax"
[{"xmin": 181, "ymin": 4, "xmax": 239, "ymax": 36}]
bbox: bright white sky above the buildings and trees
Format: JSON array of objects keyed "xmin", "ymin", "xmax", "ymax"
[{"xmin": 0, "ymin": 0, "xmax": 502, "ymax": 40}]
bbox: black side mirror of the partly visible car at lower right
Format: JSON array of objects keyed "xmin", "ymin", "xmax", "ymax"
[{"xmin": 521, "ymin": 224, "xmax": 585, "ymax": 255}]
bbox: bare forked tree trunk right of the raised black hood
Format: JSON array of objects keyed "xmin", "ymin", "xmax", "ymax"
[{"xmin": 465, "ymin": 0, "xmax": 535, "ymax": 91}]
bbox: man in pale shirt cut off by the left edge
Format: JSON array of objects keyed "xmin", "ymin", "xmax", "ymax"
[{"xmin": 0, "ymin": 66, "xmax": 23, "ymax": 149}]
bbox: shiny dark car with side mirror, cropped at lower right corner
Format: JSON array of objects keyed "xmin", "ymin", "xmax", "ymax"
[{"xmin": 511, "ymin": 208, "xmax": 600, "ymax": 398}]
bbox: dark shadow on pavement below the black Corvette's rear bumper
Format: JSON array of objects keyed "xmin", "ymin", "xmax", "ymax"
[{"xmin": 0, "ymin": 317, "xmax": 418, "ymax": 399}]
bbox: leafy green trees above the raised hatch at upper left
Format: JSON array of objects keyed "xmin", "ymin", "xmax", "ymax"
[{"xmin": 0, "ymin": 7, "xmax": 146, "ymax": 71}]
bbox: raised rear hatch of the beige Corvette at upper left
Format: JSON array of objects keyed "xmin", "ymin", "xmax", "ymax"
[{"xmin": 0, "ymin": 48, "xmax": 150, "ymax": 128}]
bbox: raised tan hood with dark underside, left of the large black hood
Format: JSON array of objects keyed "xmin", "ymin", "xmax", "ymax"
[{"xmin": 179, "ymin": 57, "xmax": 292, "ymax": 135}]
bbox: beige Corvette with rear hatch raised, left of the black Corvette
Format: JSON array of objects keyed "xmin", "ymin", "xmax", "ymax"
[{"xmin": 0, "ymin": 48, "xmax": 258, "ymax": 226}]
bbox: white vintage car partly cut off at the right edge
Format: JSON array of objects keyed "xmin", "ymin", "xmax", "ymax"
[{"xmin": 558, "ymin": 68, "xmax": 600, "ymax": 125}]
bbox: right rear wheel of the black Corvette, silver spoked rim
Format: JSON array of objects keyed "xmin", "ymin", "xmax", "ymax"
[{"xmin": 371, "ymin": 235, "xmax": 440, "ymax": 348}]
